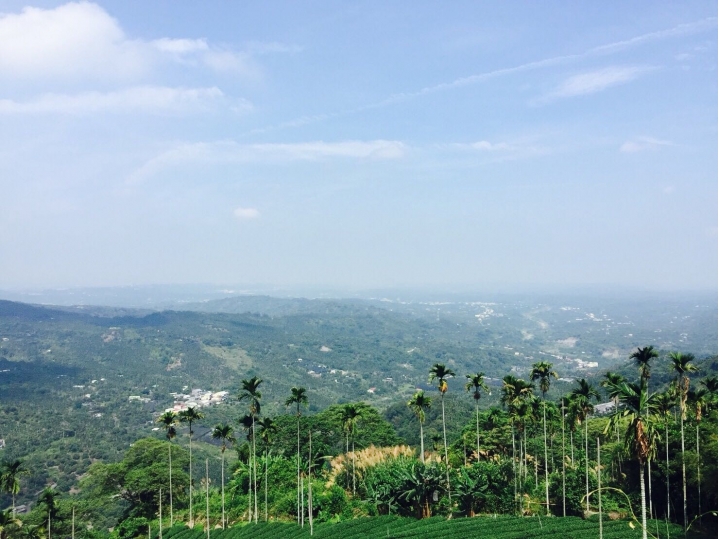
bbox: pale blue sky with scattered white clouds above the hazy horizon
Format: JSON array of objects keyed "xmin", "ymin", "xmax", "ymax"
[{"xmin": 0, "ymin": 0, "xmax": 718, "ymax": 296}]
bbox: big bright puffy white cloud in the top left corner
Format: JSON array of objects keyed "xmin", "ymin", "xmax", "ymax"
[{"xmin": 0, "ymin": 2, "xmax": 257, "ymax": 82}]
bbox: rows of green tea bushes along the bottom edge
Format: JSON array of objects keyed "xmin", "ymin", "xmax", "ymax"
[{"xmin": 153, "ymin": 516, "xmax": 683, "ymax": 539}]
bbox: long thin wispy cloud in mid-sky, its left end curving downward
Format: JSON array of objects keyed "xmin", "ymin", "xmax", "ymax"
[{"xmin": 128, "ymin": 140, "xmax": 408, "ymax": 184}]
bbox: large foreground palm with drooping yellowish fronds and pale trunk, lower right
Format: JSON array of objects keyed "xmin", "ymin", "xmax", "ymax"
[{"xmin": 605, "ymin": 379, "xmax": 657, "ymax": 539}]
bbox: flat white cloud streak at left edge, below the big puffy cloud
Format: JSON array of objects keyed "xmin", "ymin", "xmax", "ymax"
[{"xmin": 0, "ymin": 86, "xmax": 240, "ymax": 115}]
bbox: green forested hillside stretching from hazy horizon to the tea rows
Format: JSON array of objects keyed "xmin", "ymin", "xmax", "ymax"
[{"xmin": 0, "ymin": 297, "xmax": 717, "ymax": 537}]
